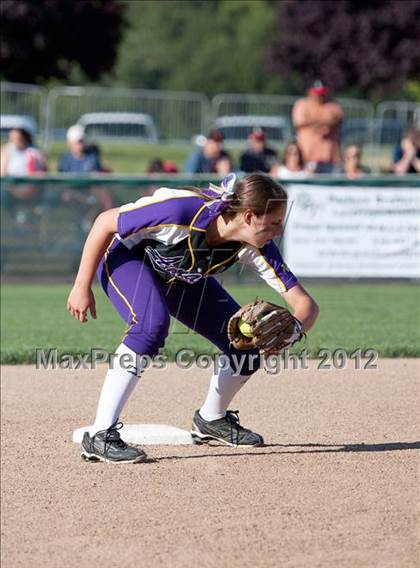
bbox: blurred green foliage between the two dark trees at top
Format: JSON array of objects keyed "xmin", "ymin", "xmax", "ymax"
[{"xmin": 115, "ymin": 0, "xmax": 282, "ymax": 95}]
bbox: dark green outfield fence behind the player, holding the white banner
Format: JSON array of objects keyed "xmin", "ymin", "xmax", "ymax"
[{"xmin": 0, "ymin": 175, "xmax": 418, "ymax": 282}]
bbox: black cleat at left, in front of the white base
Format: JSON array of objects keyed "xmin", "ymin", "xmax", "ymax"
[{"xmin": 81, "ymin": 422, "xmax": 147, "ymax": 463}]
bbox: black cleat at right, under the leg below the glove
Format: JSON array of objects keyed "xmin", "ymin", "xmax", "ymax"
[{"xmin": 191, "ymin": 410, "xmax": 264, "ymax": 447}]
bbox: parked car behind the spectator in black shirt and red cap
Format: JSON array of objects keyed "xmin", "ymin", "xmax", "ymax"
[{"xmin": 213, "ymin": 115, "xmax": 292, "ymax": 145}]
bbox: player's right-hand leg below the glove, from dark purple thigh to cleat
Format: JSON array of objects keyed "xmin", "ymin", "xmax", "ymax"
[{"xmin": 167, "ymin": 278, "xmax": 263, "ymax": 446}]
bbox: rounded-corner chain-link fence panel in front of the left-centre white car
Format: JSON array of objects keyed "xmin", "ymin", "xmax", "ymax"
[{"xmin": 45, "ymin": 87, "xmax": 209, "ymax": 146}]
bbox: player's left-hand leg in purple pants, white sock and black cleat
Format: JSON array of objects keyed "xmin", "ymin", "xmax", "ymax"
[{"xmin": 82, "ymin": 243, "xmax": 169, "ymax": 462}]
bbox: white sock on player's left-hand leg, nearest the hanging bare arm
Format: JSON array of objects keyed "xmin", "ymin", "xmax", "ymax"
[{"xmin": 91, "ymin": 343, "xmax": 143, "ymax": 434}]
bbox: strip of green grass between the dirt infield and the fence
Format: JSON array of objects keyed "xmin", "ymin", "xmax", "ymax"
[{"xmin": 1, "ymin": 283, "xmax": 420, "ymax": 364}]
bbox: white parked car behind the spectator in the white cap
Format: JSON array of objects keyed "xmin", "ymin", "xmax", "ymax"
[{"xmin": 77, "ymin": 112, "xmax": 159, "ymax": 144}]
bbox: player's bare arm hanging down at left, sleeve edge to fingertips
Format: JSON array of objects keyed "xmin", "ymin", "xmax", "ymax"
[{"xmin": 67, "ymin": 207, "xmax": 119, "ymax": 323}]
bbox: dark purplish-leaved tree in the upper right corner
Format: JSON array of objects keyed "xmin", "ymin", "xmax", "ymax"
[{"xmin": 266, "ymin": 0, "xmax": 420, "ymax": 98}]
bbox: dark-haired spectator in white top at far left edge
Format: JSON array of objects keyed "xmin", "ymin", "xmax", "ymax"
[{"xmin": 1, "ymin": 124, "xmax": 46, "ymax": 176}]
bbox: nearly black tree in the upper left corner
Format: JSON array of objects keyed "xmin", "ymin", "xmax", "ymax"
[{"xmin": 0, "ymin": 0, "xmax": 124, "ymax": 83}]
